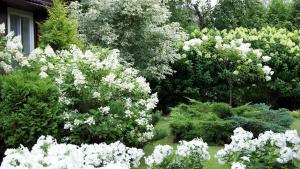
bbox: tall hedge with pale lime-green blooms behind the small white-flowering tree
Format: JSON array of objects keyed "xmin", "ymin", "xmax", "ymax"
[{"xmin": 192, "ymin": 27, "xmax": 300, "ymax": 107}]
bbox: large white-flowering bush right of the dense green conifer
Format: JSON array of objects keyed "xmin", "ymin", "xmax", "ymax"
[{"xmin": 24, "ymin": 46, "xmax": 158, "ymax": 145}]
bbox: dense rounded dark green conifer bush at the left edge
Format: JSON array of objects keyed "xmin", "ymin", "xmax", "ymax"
[{"xmin": 0, "ymin": 72, "xmax": 63, "ymax": 154}]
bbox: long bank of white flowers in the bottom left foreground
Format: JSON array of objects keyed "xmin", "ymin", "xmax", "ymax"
[{"xmin": 0, "ymin": 136, "xmax": 144, "ymax": 169}]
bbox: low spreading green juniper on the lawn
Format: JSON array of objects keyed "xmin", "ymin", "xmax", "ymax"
[{"xmin": 170, "ymin": 100, "xmax": 293, "ymax": 144}]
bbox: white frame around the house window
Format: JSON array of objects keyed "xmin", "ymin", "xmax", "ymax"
[{"xmin": 7, "ymin": 7, "xmax": 35, "ymax": 51}]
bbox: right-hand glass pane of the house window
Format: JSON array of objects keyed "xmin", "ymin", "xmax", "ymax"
[{"xmin": 21, "ymin": 17, "xmax": 30, "ymax": 55}]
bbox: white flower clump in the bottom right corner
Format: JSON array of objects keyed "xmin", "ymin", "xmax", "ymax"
[{"xmin": 216, "ymin": 128, "xmax": 300, "ymax": 169}]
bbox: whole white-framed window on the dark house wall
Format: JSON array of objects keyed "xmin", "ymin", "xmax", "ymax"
[{"xmin": 7, "ymin": 8, "xmax": 34, "ymax": 55}]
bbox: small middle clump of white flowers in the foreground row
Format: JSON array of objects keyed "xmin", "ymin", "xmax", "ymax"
[{"xmin": 145, "ymin": 139, "xmax": 210, "ymax": 169}]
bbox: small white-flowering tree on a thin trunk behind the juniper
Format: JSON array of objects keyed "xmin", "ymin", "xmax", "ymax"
[{"xmin": 182, "ymin": 29, "xmax": 274, "ymax": 104}]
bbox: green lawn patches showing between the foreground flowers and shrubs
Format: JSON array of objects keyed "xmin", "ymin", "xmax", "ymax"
[{"xmin": 139, "ymin": 117, "xmax": 300, "ymax": 169}]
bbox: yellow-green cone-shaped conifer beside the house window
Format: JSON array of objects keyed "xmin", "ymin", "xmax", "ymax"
[{"xmin": 39, "ymin": 0, "xmax": 83, "ymax": 50}]
